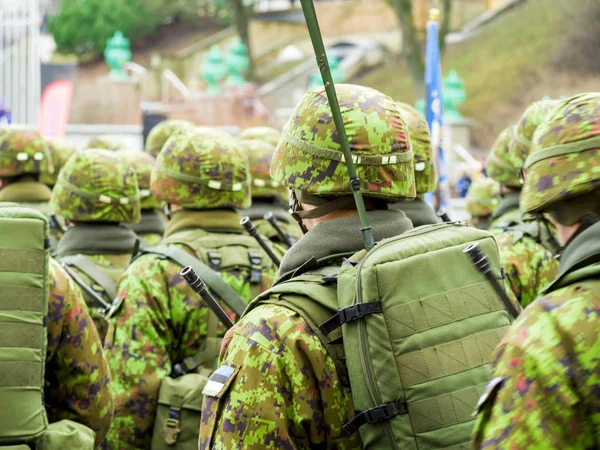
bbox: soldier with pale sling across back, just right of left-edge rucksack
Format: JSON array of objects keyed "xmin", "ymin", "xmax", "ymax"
[{"xmin": 52, "ymin": 149, "xmax": 140, "ymax": 339}]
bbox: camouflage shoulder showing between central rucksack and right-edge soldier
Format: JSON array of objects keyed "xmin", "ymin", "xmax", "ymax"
[{"xmin": 496, "ymin": 231, "xmax": 559, "ymax": 308}]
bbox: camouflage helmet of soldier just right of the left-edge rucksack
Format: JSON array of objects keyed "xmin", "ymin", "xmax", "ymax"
[{"xmin": 51, "ymin": 149, "xmax": 140, "ymax": 223}]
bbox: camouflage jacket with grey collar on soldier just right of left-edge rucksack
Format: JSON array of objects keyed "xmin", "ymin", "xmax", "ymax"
[{"xmin": 54, "ymin": 223, "xmax": 137, "ymax": 341}]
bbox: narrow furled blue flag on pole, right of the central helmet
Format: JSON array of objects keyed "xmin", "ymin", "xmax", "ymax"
[{"xmin": 425, "ymin": 14, "xmax": 450, "ymax": 209}]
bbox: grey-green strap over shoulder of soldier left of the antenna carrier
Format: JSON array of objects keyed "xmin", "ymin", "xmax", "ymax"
[{"xmin": 143, "ymin": 246, "xmax": 246, "ymax": 317}]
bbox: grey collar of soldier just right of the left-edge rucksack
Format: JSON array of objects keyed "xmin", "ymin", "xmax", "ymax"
[{"xmin": 54, "ymin": 223, "xmax": 137, "ymax": 259}]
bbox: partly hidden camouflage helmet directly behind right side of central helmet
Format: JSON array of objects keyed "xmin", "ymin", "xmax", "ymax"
[{"xmin": 396, "ymin": 102, "xmax": 437, "ymax": 195}]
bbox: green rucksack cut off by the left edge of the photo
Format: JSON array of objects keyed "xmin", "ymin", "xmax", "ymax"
[{"xmin": 0, "ymin": 204, "xmax": 94, "ymax": 450}]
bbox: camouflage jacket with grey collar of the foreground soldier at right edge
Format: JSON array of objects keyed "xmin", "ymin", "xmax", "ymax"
[{"xmin": 474, "ymin": 224, "xmax": 600, "ymax": 450}]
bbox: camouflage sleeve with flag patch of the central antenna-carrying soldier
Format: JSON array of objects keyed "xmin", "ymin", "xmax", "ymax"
[{"xmin": 199, "ymin": 305, "xmax": 362, "ymax": 450}]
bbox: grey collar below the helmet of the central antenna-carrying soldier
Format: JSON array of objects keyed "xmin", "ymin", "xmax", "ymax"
[{"xmin": 279, "ymin": 209, "xmax": 413, "ymax": 274}]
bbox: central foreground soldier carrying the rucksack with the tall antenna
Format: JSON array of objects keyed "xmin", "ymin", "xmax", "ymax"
[{"xmin": 199, "ymin": 85, "xmax": 415, "ymax": 450}]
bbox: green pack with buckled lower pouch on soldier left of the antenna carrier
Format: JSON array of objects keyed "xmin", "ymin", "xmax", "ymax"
[{"xmin": 135, "ymin": 229, "xmax": 272, "ymax": 450}]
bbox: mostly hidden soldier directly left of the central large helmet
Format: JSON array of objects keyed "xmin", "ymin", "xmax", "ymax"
[{"xmin": 238, "ymin": 139, "xmax": 302, "ymax": 248}]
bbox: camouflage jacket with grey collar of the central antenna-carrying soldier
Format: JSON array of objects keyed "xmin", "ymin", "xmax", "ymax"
[{"xmin": 199, "ymin": 210, "xmax": 412, "ymax": 450}]
